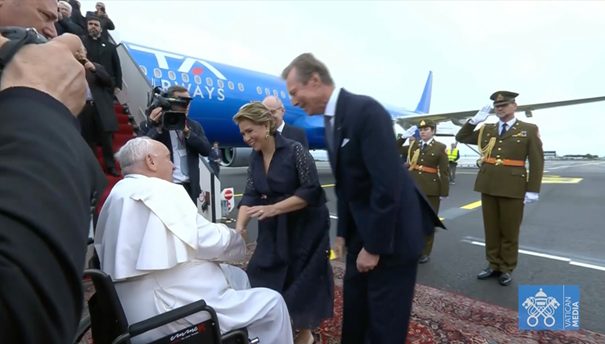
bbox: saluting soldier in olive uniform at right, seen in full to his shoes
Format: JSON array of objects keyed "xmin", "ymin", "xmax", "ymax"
[{"xmin": 456, "ymin": 91, "xmax": 544, "ymax": 286}]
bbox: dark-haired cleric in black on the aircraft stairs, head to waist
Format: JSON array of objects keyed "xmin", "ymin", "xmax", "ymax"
[{"xmin": 82, "ymin": 16, "xmax": 122, "ymax": 93}]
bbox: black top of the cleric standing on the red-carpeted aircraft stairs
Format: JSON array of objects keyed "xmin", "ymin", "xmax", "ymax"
[{"xmin": 80, "ymin": 35, "xmax": 122, "ymax": 89}]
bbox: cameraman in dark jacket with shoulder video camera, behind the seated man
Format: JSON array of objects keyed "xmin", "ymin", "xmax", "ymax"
[{"xmin": 141, "ymin": 86, "xmax": 211, "ymax": 204}]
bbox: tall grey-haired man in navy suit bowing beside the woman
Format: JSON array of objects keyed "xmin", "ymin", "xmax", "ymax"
[{"xmin": 282, "ymin": 54, "xmax": 442, "ymax": 344}]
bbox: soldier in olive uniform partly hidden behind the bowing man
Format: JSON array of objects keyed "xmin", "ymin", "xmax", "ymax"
[{"xmin": 400, "ymin": 120, "xmax": 449, "ymax": 264}]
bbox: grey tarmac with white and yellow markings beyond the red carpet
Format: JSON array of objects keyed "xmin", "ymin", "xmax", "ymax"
[{"xmin": 221, "ymin": 160, "xmax": 605, "ymax": 333}]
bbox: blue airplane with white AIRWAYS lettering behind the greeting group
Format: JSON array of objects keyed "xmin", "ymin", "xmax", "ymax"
[{"xmin": 118, "ymin": 42, "xmax": 605, "ymax": 166}]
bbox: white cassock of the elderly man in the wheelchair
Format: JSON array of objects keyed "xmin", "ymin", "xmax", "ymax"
[{"xmin": 95, "ymin": 174, "xmax": 292, "ymax": 344}]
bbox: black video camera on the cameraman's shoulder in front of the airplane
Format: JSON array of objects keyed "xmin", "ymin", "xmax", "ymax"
[{"xmin": 147, "ymin": 86, "xmax": 191, "ymax": 130}]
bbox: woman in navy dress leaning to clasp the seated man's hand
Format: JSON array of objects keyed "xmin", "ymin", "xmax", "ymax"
[{"xmin": 233, "ymin": 102, "xmax": 334, "ymax": 343}]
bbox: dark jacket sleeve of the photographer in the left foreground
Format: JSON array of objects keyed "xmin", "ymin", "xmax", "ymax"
[{"xmin": 0, "ymin": 87, "xmax": 106, "ymax": 343}]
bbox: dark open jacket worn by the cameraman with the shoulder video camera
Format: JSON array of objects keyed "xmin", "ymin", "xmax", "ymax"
[{"xmin": 141, "ymin": 118, "xmax": 212, "ymax": 199}]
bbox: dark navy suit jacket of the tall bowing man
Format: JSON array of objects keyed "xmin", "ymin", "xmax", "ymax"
[{"xmin": 330, "ymin": 89, "xmax": 443, "ymax": 263}]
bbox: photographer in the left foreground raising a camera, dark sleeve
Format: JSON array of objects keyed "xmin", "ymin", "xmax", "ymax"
[{"xmin": 0, "ymin": 25, "xmax": 102, "ymax": 343}]
